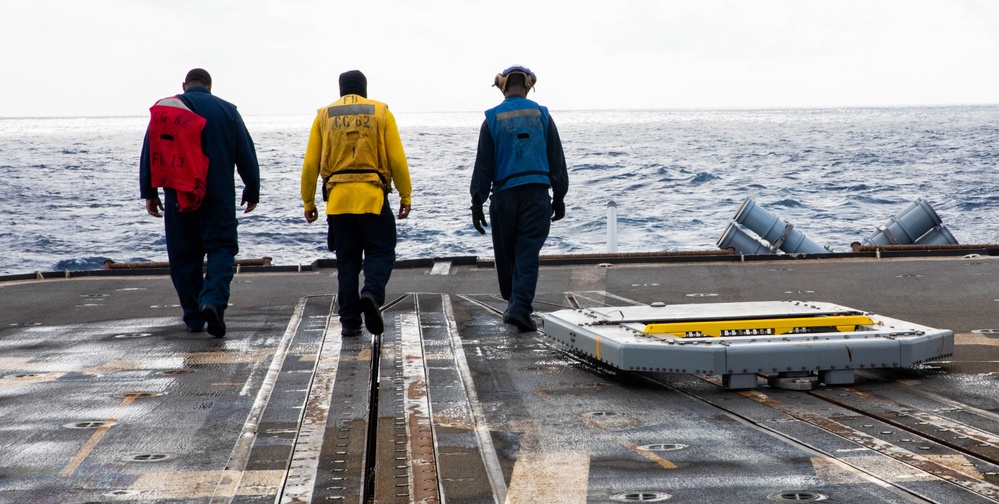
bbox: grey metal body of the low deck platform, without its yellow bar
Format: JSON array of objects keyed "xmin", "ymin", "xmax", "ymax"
[{"xmin": 542, "ymin": 301, "xmax": 954, "ymax": 382}]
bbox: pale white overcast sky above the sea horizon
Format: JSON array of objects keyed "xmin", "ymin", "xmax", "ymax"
[{"xmin": 0, "ymin": 0, "xmax": 999, "ymax": 117}]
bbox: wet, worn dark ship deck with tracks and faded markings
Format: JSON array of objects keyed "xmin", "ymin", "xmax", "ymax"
[{"xmin": 0, "ymin": 256, "xmax": 999, "ymax": 504}]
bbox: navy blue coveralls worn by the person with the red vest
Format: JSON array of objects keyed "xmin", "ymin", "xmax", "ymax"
[{"xmin": 139, "ymin": 86, "xmax": 260, "ymax": 328}]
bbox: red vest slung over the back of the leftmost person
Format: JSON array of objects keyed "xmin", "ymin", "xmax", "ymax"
[{"xmin": 149, "ymin": 96, "xmax": 208, "ymax": 212}]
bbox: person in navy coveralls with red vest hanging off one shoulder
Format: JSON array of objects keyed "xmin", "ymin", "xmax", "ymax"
[{"xmin": 139, "ymin": 68, "xmax": 260, "ymax": 337}]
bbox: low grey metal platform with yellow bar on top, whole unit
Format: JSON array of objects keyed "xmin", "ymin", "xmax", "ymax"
[{"xmin": 542, "ymin": 301, "xmax": 954, "ymax": 389}]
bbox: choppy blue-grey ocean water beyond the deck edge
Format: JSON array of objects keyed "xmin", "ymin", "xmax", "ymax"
[{"xmin": 0, "ymin": 105, "xmax": 999, "ymax": 275}]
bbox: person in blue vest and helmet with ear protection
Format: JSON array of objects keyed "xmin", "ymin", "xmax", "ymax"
[{"xmin": 471, "ymin": 66, "xmax": 569, "ymax": 332}]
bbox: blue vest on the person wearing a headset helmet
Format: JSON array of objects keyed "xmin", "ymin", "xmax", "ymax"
[{"xmin": 486, "ymin": 97, "xmax": 551, "ymax": 193}]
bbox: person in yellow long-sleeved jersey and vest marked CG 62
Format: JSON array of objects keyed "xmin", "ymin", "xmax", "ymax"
[{"xmin": 302, "ymin": 70, "xmax": 413, "ymax": 336}]
